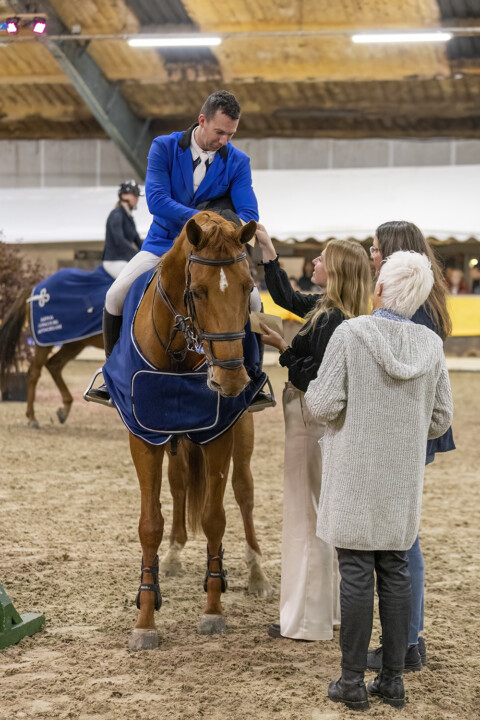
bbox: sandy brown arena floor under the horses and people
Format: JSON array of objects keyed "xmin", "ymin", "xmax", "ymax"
[{"xmin": 0, "ymin": 361, "xmax": 480, "ymax": 720}]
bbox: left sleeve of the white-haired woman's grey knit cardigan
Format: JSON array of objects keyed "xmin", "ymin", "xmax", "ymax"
[{"xmin": 305, "ymin": 323, "xmax": 347, "ymax": 422}]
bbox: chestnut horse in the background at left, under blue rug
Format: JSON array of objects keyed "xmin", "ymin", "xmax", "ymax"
[{"xmin": 0, "ymin": 289, "xmax": 103, "ymax": 428}]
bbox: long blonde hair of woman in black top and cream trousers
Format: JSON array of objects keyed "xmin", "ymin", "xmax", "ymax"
[{"xmin": 300, "ymin": 240, "xmax": 372, "ymax": 335}]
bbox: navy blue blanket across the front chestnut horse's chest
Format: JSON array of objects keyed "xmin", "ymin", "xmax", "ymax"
[{"xmin": 103, "ymin": 270, "xmax": 267, "ymax": 445}]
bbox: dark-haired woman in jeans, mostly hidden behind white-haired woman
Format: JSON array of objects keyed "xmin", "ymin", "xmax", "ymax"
[{"xmin": 368, "ymin": 220, "xmax": 455, "ymax": 672}]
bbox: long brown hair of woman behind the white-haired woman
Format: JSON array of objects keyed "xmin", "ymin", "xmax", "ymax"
[{"xmin": 375, "ymin": 220, "xmax": 452, "ymax": 340}]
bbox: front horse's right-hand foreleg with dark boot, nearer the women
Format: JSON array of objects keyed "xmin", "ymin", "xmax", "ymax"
[{"xmin": 198, "ymin": 430, "xmax": 233, "ymax": 635}]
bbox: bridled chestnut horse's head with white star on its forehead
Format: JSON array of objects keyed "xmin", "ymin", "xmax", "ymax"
[{"xmin": 185, "ymin": 211, "xmax": 257, "ymax": 397}]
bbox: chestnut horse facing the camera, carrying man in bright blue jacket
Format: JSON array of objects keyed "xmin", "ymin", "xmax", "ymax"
[{"xmin": 129, "ymin": 211, "xmax": 265, "ymax": 650}]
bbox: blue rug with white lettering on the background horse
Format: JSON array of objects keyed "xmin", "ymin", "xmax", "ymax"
[{"xmin": 28, "ymin": 265, "xmax": 113, "ymax": 346}]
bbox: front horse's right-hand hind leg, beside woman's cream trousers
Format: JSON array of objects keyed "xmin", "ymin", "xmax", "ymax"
[{"xmin": 232, "ymin": 413, "xmax": 273, "ymax": 597}]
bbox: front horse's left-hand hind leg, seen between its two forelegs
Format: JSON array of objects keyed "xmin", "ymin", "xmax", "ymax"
[{"xmin": 160, "ymin": 441, "xmax": 189, "ymax": 576}]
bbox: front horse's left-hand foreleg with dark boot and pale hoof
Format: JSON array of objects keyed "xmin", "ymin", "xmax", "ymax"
[{"xmin": 129, "ymin": 434, "xmax": 164, "ymax": 650}]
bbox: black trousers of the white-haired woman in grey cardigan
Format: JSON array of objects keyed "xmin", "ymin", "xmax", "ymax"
[{"xmin": 337, "ymin": 548, "xmax": 411, "ymax": 673}]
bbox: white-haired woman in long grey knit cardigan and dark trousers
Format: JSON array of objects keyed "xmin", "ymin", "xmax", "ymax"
[{"xmin": 305, "ymin": 251, "xmax": 453, "ymax": 710}]
